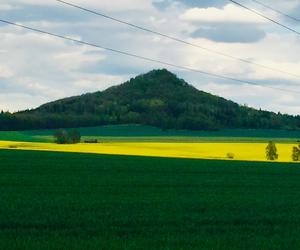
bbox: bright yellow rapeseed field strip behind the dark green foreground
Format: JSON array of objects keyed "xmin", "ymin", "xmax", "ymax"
[{"xmin": 0, "ymin": 141, "xmax": 295, "ymax": 162}]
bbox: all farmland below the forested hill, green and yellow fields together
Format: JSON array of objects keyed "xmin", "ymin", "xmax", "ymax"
[{"xmin": 0, "ymin": 125, "xmax": 300, "ymax": 250}]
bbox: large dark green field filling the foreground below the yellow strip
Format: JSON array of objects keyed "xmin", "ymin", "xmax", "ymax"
[{"xmin": 0, "ymin": 150, "xmax": 300, "ymax": 250}]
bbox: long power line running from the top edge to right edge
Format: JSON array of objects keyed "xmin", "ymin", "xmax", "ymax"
[{"xmin": 55, "ymin": 0, "xmax": 300, "ymax": 78}]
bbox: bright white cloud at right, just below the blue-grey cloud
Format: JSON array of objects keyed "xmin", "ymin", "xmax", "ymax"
[{"xmin": 178, "ymin": 31, "xmax": 300, "ymax": 82}]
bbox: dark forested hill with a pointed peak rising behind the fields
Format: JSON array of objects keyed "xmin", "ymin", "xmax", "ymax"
[{"xmin": 0, "ymin": 69, "xmax": 300, "ymax": 130}]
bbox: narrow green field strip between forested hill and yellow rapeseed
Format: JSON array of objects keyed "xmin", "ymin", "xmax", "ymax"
[{"xmin": 0, "ymin": 125, "xmax": 300, "ymax": 142}]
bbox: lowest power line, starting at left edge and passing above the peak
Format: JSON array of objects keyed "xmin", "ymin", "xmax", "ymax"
[{"xmin": 0, "ymin": 19, "xmax": 300, "ymax": 94}]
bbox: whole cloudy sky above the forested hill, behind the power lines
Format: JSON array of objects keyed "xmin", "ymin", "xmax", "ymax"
[{"xmin": 0, "ymin": 0, "xmax": 300, "ymax": 114}]
